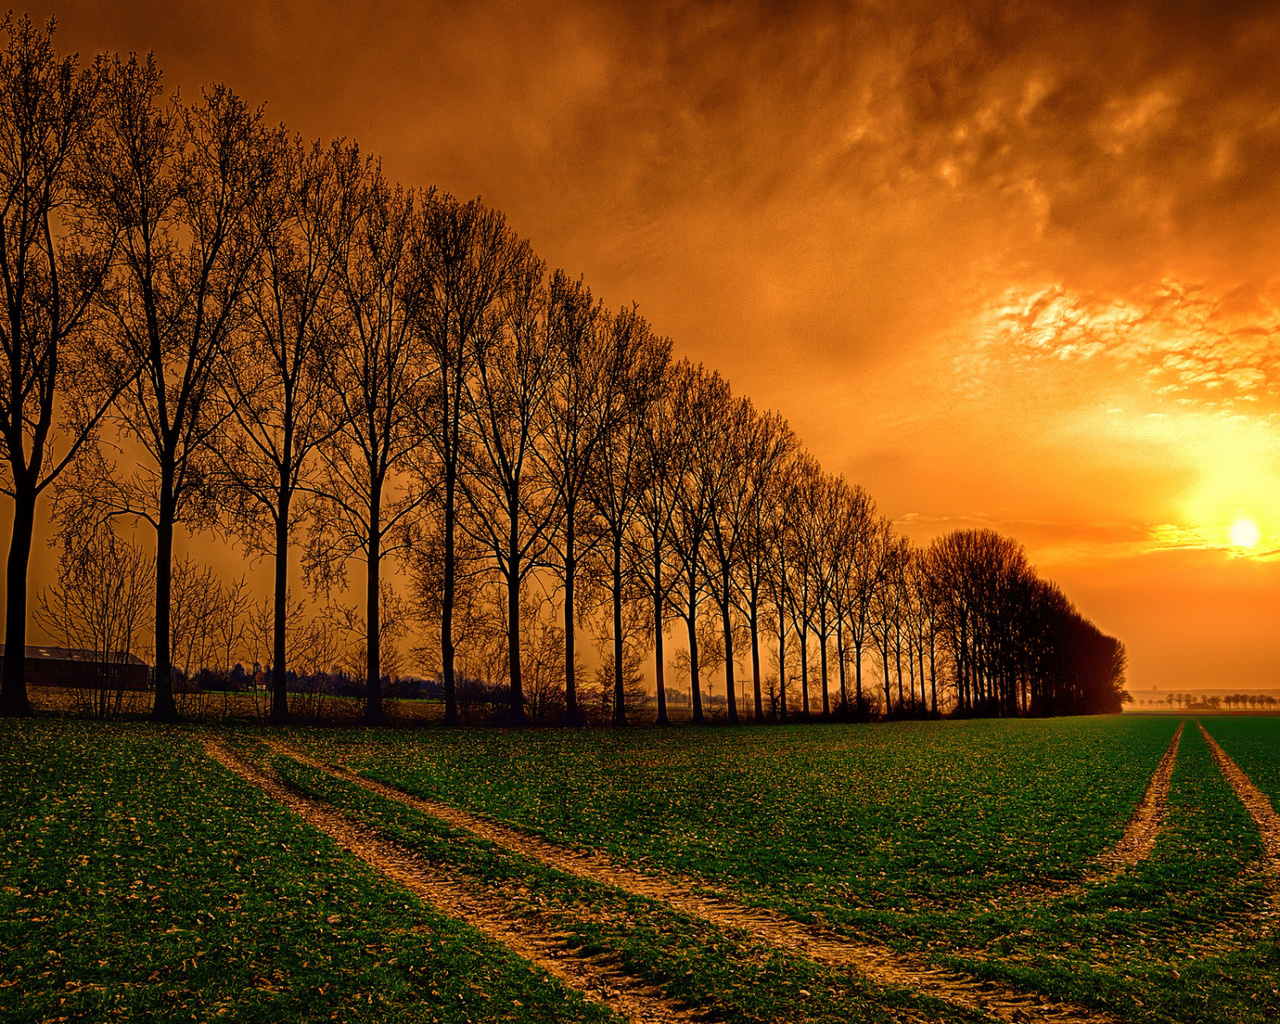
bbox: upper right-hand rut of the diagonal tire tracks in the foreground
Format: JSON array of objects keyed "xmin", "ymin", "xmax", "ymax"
[{"xmin": 264, "ymin": 740, "xmax": 1114, "ymax": 1024}]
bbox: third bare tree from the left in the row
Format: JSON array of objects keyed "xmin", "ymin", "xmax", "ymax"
[{"xmin": 219, "ymin": 134, "xmax": 365, "ymax": 724}]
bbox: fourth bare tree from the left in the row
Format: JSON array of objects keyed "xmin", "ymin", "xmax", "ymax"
[{"xmin": 306, "ymin": 169, "xmax": 431, "ymax": 722}]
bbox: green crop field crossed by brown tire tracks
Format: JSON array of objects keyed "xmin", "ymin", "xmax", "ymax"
[{"xmin": 0, "ymin": 716, "xmax": 1280, "ymax": 1023}]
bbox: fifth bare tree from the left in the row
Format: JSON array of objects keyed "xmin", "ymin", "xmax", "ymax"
[{"xmin": 411, "ymin": 196, "xmax": 530, "ymax": 724}]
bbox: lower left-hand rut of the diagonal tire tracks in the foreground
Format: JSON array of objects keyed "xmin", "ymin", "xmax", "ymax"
[{"xmin": 200, "ymin": 737, "xmax": 709, "ymax": 1024}]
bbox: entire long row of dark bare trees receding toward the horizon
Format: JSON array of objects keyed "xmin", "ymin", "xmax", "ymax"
[{"xmin": 0, "ymin": 19, "xmax": 1125, "ymax": 724}]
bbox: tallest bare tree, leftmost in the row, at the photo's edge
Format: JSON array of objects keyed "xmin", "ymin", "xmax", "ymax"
[{"xmin": 0, "ymin": 14, "xmax": 119, "ymax": 714}]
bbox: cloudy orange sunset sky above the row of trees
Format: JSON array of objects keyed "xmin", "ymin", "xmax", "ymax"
[{"xmin": 15, "ymin": 0, "xmax": 1280, "ymax": 695}]
